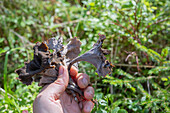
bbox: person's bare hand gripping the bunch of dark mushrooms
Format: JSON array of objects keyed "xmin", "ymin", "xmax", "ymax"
[{"xmin": 33, "ymin": 66, "xmax": 94, "ymax": 113}]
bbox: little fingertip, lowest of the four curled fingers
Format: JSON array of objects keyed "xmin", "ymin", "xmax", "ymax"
[{"xmin": 82, "ymin": 101, "xmax": 94, "ymax": 113}]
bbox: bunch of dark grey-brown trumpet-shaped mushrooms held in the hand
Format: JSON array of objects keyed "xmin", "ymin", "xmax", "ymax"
[{"xmin": 16, "ymin": 34, "xmax": 112, "ymax": 100}]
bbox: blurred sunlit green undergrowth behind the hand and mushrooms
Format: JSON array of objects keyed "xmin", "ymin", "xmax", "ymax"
[{"xmin": 0, "ymin": 0, "xmax": 170, "ymax": 113}]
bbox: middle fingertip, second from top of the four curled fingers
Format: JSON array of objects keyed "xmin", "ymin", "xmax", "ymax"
[{"xmin": 76, "ymin": 73, "xmax": 90, "ymax": 89}]
